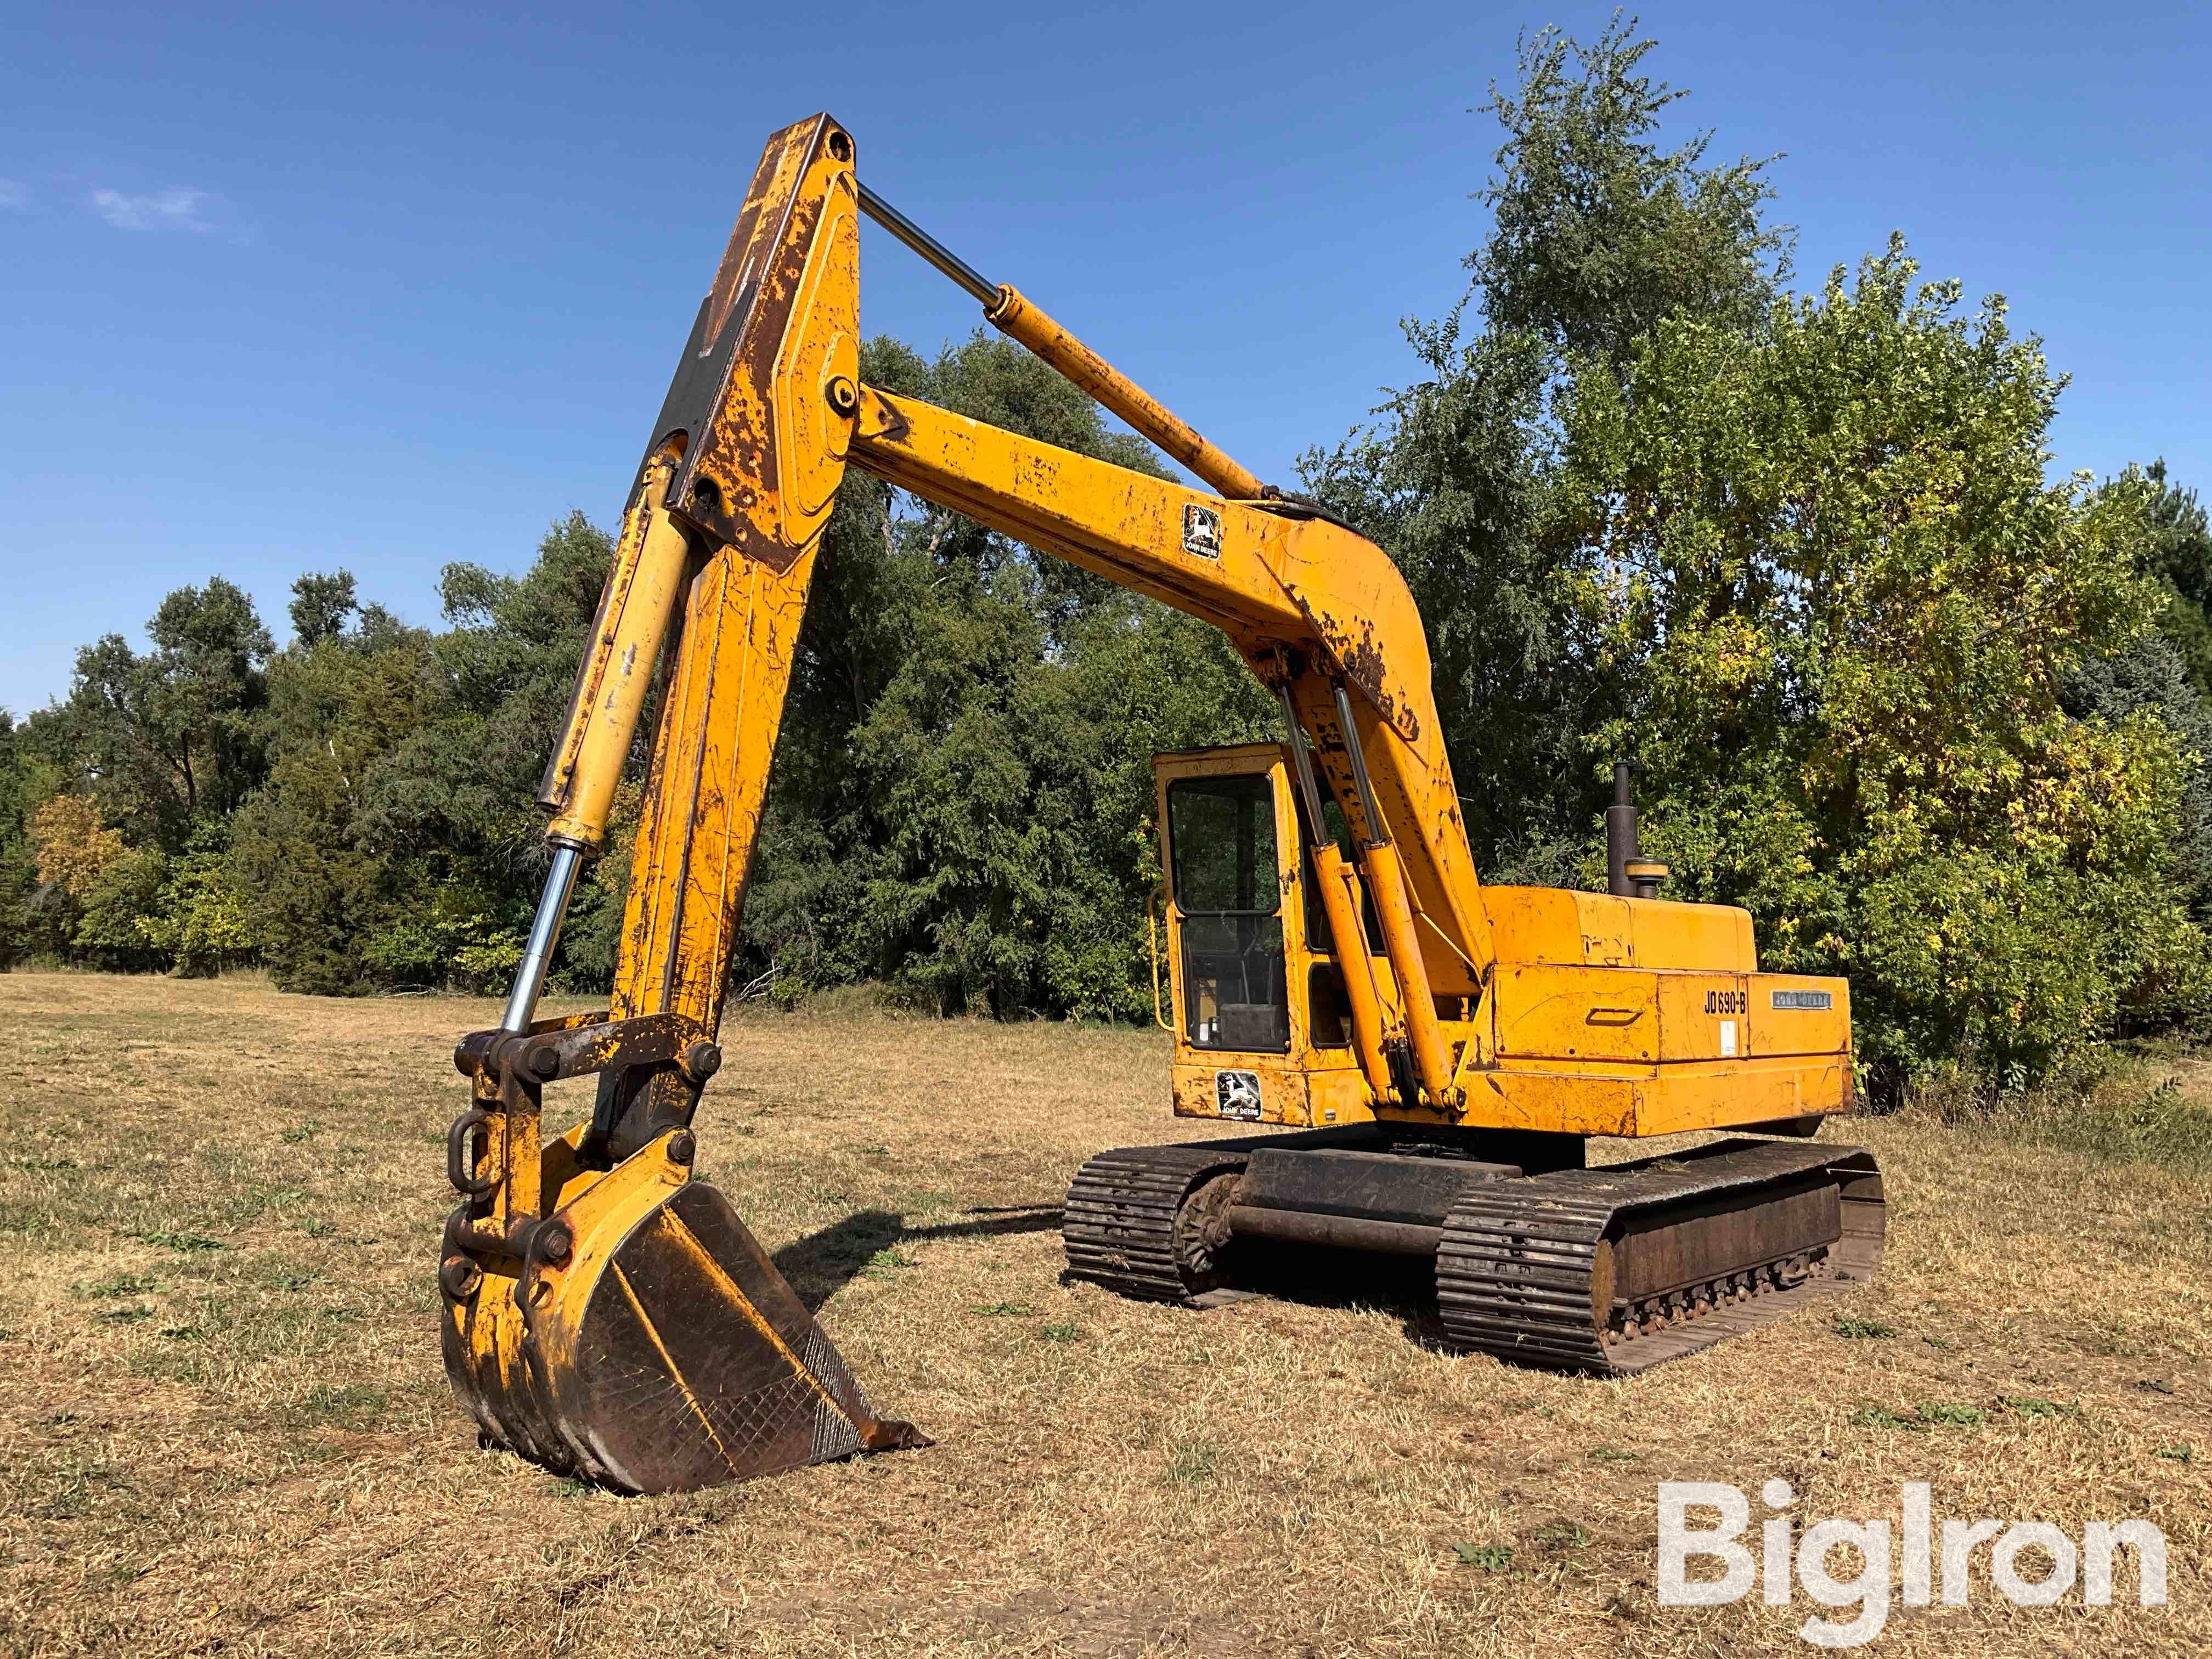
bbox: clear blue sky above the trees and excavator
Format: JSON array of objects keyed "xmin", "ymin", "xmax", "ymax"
[{"xmin": 0, "ymin": 0, "xmax": 2212, "ymax": 710}]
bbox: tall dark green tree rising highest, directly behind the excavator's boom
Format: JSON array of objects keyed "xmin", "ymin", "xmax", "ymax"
[{"xmin": 1301, "ymin": 15, "xmax": 1790, "ymax": 883}]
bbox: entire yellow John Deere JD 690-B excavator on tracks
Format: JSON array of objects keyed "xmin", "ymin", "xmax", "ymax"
[{"xmin": 438, "ymin": 115, "xmax": 1884, "ymax": 1491}]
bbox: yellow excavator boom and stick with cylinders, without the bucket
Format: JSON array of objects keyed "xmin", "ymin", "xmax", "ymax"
[{"xmin": 537, "ymin": 115, "xmax": 1491, "ymax": 1150}]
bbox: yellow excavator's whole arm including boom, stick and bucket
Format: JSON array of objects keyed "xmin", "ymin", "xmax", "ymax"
[{"xmin": 442, "ymin": 115, "xmax": 1489, "ymax": 1491}]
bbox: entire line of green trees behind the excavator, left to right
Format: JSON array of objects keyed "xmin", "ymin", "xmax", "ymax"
[{"xmin": 0, "ymin": 22, "xmax": 2212, "ymax": 1106}]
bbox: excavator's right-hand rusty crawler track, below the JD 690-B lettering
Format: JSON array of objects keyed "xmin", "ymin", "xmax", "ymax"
[{"xmin": 1436, "ymin": 1142, "xmax": 1884, "ymax": 1376}]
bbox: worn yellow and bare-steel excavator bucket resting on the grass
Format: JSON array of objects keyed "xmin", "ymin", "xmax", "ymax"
[{"xmin": 444, "ymin": 1130, "xmax": 929, "ymax": 1493}]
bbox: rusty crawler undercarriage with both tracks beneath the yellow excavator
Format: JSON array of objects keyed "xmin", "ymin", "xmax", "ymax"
[{"xmin": 1062, "ymin": 1126, "xmax": 1884, "ymax": 1376}]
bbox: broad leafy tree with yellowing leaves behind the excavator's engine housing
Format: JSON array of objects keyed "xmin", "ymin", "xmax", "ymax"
[{"xmin": 1562, "ymin": 241, "xmax": 2203, "ymax": 1082}]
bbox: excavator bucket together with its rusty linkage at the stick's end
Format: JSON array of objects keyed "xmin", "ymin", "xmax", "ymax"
[{"xmin": 438, "ymin": 986, "xmax": 927, "ymax": 1491}]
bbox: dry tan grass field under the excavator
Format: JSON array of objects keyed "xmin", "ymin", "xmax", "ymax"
[{"xmin": 0, "ymin": 973, "xmax": 2212, "ymax": 1657}]
